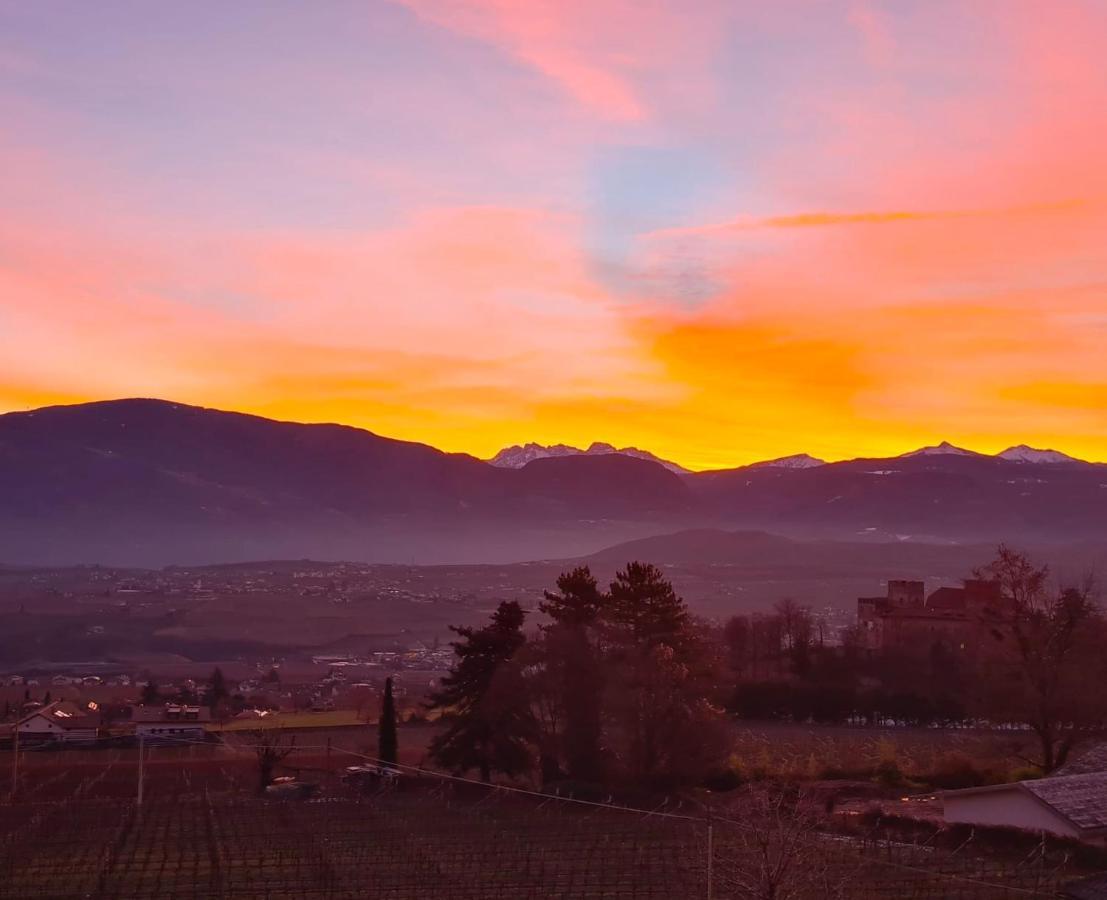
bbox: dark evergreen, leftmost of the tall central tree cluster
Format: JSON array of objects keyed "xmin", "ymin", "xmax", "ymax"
[{"xmin": 427, "ymin": 600, "xmax": 535, "ymax": 782}]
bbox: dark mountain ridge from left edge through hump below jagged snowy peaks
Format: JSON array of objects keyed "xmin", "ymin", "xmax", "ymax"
[{"xmin": 0, "ymin": 400, "xmax": 693, "ymax": 563}]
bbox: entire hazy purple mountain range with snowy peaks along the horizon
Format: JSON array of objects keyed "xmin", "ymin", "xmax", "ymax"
[{"xmin": 0, "ymin": 400, "xmax": 1107, "ymax": 565}]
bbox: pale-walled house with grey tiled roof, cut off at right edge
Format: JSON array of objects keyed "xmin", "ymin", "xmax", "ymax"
[{"xmin": 942, "ymin": 772, "xmax": 1107, "ymax": 847}]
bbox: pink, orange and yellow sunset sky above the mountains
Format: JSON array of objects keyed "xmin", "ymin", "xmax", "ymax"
[{"xmin": 0, "ymin": 0, "xmax": 1107, "ymax": 468}]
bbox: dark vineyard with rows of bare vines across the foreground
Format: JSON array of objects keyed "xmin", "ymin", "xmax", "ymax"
[{"xmin": 0, "ymin": 755, "xmax": 1090, "ymax": 900}]
